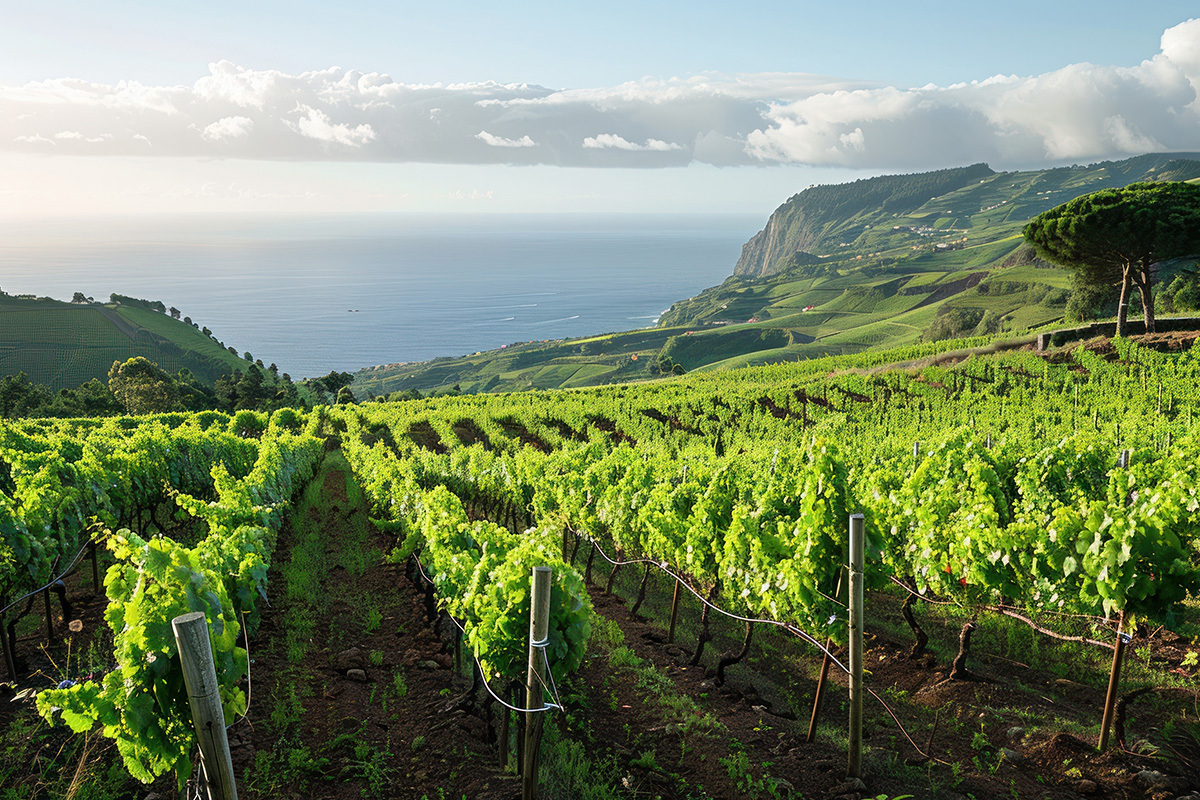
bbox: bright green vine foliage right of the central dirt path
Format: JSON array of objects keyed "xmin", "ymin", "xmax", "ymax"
[{"xmin": 331, "ymin": 342, "xmax": 1200, "ymax": 705}]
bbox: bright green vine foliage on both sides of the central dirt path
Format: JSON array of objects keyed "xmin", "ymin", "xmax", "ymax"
[{"xmin": 9, "ymin": 333, "xmax": 1200, "ymax": 780}]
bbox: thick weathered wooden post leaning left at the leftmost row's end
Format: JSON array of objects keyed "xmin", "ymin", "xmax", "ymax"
[{"xmin": 170, "ymin": 612, "xmax": 238, "ymax": 800}]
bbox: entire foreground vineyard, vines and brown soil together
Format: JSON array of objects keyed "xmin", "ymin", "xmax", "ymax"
[{"xmin": 0, "ymin": 339, "xmax": 1200, "ymax": 800}]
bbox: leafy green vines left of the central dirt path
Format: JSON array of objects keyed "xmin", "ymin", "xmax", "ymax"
[{"xmin": 0, "ymin": 409, "xmax": 323, "ymax": 782}]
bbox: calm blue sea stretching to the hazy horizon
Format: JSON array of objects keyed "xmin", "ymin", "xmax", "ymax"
[{"xmin": 0, "ymin": 213, "xmax": 764, "ymax": 378}]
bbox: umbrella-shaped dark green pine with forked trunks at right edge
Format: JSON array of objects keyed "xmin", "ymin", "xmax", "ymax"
[{"xmin": 1024, "ymin": 181, "xmax": 1200, "ymax": 333}]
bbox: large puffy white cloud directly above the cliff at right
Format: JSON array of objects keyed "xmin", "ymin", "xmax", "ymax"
[{"xmin": 746, "ymin": 20, "xmax": 1200, "ymax": 167}]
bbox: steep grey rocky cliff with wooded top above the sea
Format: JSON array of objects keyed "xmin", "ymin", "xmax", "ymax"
[{"xmin": 733, "ymin": 164, "xmax": 996, "ymax": 277}]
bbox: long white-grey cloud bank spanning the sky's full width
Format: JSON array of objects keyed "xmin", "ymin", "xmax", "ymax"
[{"xmin": 7, "ymin": 19, "xmax": 1200, "ymax": 169}]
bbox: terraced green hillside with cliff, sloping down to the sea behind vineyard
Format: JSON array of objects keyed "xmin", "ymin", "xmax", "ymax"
[{"xmin": 352, "ymin": 154, "xmax": 1200, "ymax": 398}]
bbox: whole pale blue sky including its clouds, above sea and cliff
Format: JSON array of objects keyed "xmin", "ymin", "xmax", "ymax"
[{"xmin": 0, "ymin": 0, "xmax": 1200, "ymax": 218}]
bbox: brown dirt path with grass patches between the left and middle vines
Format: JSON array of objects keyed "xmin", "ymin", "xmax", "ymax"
[{"xmin": 237, "ymin": 453, "xmax": 520, "ymax": 800}]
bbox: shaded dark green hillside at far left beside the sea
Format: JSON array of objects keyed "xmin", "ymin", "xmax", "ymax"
[{"xmin": 0, "ymin": 294, "xmax": 247, "ymax": 391}]
